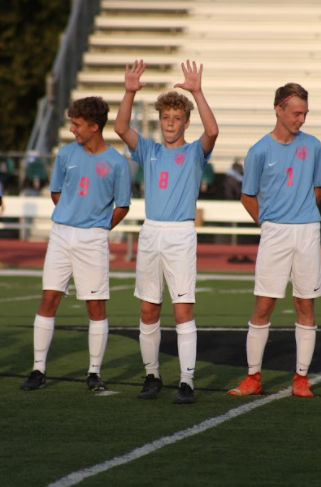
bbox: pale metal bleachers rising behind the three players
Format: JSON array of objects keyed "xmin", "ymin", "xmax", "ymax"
[{"xmin": 59, "ymin": 0, "xmax": 321, "ymax": 173}]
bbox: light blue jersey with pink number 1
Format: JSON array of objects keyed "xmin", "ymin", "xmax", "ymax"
[{"xmin": 242, "ymin": 132, "xmax": 321, "ymax": 224}]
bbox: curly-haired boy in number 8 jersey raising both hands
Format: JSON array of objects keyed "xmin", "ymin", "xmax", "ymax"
[{"xmin": 115, "ymin": 60, "xmax": 218, "ymax": 404}]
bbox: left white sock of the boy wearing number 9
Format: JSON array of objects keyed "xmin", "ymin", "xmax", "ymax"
[{"xmin": 33, "ymin": 314, "xmax": 55, "ymax": 374}]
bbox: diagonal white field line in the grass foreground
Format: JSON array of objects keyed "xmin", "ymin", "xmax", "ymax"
[{"xmin": 47, "ymin": 375, "xmax": 321, "ymax": 487}]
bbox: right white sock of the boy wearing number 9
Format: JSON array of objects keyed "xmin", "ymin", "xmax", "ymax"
[{"xmin": 88, "ymin": 319, "xmax": 108, "ymax": 375}]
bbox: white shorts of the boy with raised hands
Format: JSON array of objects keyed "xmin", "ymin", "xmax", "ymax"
[{"xmin": 134, "ymin": 220, "xmax": 197, "ymax": 304}]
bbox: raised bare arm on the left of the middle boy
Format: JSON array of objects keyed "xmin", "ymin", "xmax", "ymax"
[{"xmin": 114, "ymin": 60, "xmax": 146, "ymax": 150}]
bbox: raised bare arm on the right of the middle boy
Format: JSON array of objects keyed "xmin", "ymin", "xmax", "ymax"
[{"xmin": 174, "ymin": 60, "xmax": 219, "ymax": 156}]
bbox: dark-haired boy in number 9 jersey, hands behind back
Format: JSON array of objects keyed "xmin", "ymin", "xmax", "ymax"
[{"xmin": 20, "ymin": 97, "xmax": 131, "ymax": 391}]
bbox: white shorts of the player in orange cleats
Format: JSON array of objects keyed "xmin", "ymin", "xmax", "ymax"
[{"xmin": 254, "ymin": 222, "xmax": 321, "ymax": 299}]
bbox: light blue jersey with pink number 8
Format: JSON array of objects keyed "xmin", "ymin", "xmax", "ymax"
[{"xmin": 130, "ymin": 135, "xmax": 211, "ymax": 222}]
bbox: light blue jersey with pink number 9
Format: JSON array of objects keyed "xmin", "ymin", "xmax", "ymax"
[{"xmin": 50, "ymin": 142, "xmax": 131, "ymax": 229}]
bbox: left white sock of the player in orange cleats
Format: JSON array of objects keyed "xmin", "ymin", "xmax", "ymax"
[{"xmin": 246, "ymin": 321, "xmax": 271, "ymax": 375}]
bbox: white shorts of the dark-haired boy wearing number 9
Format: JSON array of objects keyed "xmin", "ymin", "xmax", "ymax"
[{"xmin": 43, "ymin": 223, "xmax": 109, "ymax": 301}]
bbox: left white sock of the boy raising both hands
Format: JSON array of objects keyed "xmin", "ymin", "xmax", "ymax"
[{"xmin": 139, "ymin": 320, "xmax": 161, "ymax": 378}]
